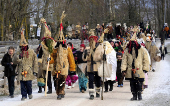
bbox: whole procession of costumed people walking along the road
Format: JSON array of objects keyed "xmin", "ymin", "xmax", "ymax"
[{"xmin": 1, "ymin": 13, "xmax": 167, "ymax": 101}]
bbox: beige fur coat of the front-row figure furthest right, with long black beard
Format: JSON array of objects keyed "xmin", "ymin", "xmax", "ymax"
[{"xmin": 121, "ymin": 47, "xmax": 149, "ymax": 79}]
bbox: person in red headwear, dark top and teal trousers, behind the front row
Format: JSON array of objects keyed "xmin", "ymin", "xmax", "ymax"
[{"xmin": 75, "ymin": 44, "xmax": 88, "ymax": 93}]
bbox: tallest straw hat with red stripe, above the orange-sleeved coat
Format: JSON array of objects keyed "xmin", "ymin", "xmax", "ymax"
[{"xmin": 56, "ymin": 11, "xmax": 66, "ymax": 42}]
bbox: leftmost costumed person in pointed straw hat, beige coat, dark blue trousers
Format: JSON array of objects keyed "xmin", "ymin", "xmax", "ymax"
[{"xmin": 12, "ymin": 29, "xmax": 38, "ymax": 101}]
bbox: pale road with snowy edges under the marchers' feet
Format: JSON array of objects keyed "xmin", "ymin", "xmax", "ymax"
[{"xmin": 0, "ymin": 40, "xmax": 170, "ymax": 106}]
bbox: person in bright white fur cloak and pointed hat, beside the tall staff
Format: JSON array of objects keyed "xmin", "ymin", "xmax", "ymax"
[{"xmin": 100, "ymin": 35, "xmax": 117, "ymax": 92}]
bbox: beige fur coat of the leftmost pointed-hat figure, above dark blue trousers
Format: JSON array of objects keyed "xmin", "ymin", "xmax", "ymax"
[{"xmin": 12, "ymin": 49, "xmax": 38, "ymax": 81}]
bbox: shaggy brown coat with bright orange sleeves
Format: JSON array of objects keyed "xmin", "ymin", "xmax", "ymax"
[{"xmin": 50, "ymin": 45, "xmax": 76, "ymax": 75}]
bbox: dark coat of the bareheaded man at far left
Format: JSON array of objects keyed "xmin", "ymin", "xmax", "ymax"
[{"xmin": 1, "ymin": 53, "xmax": 16, "ymax": 77}]
